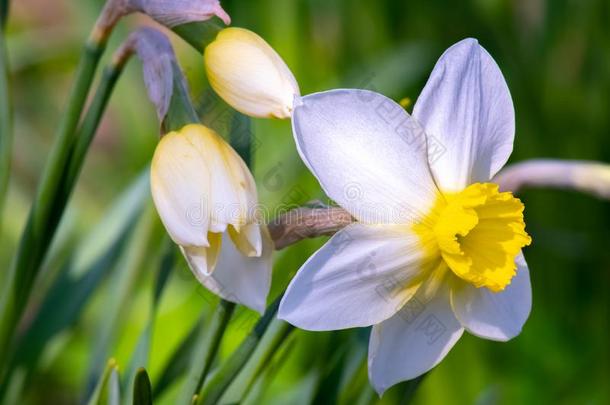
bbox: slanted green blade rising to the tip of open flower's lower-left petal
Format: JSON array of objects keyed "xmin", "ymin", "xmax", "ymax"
[{"xmin": 196, "ymin": 297, "xmax": 281, "ymax": 405}]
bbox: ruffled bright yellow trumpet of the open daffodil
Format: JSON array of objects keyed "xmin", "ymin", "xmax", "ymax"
[{"xmin": 414, "ymin": 183, "xmax": 531, "ymax": 292}]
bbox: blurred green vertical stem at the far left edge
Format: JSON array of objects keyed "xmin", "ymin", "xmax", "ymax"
[{"xmin": 0, "ymin": 27, "xmax": 13, "ymax": 228}]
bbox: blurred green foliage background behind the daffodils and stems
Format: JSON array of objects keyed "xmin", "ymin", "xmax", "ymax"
[{"xmin": 0, "ymin": 0, "xmax": 610, "ymax": 404}]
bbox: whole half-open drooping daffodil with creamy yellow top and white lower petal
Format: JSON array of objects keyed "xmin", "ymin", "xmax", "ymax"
[{"xmin": 151, "ymin": 124, "xmax": 273, "ymax": 313}]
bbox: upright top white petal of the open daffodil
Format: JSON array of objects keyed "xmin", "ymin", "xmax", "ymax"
[{"xmin": 413, "ymin": 39, "xmax": 515, "ymax": 191}]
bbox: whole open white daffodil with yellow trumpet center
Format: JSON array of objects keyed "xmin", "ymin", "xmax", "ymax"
[{"xmin": 279, "ymin": 39, "xmax": 531, "ymax": 394}]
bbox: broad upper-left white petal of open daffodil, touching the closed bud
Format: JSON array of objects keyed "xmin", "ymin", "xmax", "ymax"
[{"xmin": 292, "ymin": 90, "xmax": 437, "ymax": 224}]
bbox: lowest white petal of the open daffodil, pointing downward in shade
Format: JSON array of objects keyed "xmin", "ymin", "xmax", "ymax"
[{"xmin": 369, "ymin": 286, "xmax": 464, "ymax": 395}]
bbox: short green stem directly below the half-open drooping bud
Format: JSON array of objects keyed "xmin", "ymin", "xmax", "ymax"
[{"xmin": 178, "ymin": 300, "xmax": 235, "ymax": 404}]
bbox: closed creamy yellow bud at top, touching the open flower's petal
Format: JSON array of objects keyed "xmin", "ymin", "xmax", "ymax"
[{"xmin": 204, "ymin": 28, "xmax": 300, "ymax": 118}]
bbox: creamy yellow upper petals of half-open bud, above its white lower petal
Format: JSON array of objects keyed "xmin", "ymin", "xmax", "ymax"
[{"xmin": 151, "ymin": 121, "xmax": 261, "ymax": 266}]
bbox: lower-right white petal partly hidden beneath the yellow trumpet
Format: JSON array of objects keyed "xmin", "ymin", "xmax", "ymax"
[{"xmin": 451, "ymin": 254, "xmax": 532, "ymax": 341}]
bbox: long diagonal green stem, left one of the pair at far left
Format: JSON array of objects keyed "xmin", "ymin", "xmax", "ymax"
[{"xmin": 0, "ymin": 19, "xmax": 111, "ymax": 374}]
